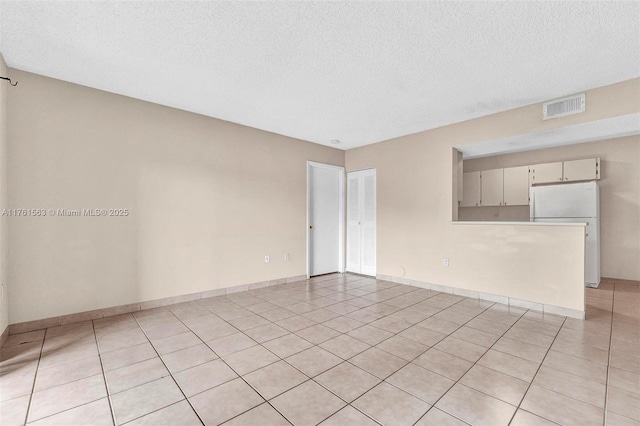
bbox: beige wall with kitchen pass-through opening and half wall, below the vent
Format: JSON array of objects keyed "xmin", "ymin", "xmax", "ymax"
[{"xmin": 345, "ymin": 79, "xmax": 640, "ymax": 309}]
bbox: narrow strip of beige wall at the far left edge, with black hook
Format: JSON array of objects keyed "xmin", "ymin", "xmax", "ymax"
[{"xmin": 0, "ymin": 55, "xmax": 8, "ymax": 334}]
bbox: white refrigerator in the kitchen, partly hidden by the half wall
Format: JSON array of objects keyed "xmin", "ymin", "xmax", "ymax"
[{"xmin": 529, "ymin": 181, "xmax": 600, "ymax": 287}]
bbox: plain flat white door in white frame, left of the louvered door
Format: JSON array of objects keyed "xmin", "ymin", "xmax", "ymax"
[{"xmin": 307, "ymin": 162, "xmax": 344, "ymax": 276}]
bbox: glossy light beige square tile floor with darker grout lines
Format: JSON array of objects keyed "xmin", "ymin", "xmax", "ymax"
[{"xmin": 0, "ymin": 275, "xmax": 640, "ymax": 426}]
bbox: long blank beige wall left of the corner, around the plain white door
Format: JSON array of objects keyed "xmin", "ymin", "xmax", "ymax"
[{"xmin": 8, "ymin": 70, "xmax": 344, "ymax": 323}]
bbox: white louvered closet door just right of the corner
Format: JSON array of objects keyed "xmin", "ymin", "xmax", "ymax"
[{"xmin": 347, "ymin": 169, "xmax": 376, "ymax": 276}]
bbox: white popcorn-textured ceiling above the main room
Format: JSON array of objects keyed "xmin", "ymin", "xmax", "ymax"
[{"xmin": 0, "ymin": 1, "xmax": 640, "ymax": 149}]
